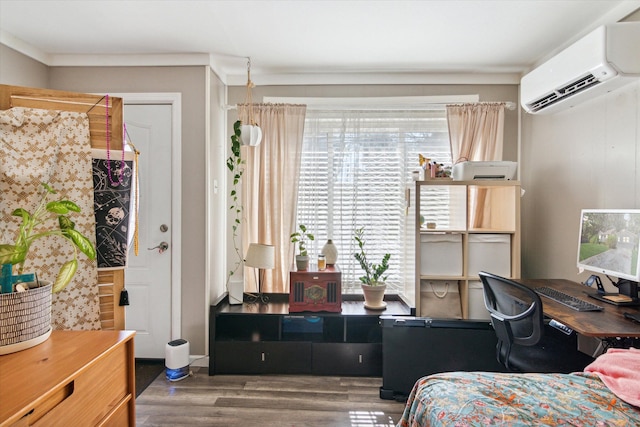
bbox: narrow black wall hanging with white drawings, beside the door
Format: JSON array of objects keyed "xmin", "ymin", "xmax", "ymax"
[{"xmin": 91, "ymin": 149, "xmax": 135, "ymax": 270}]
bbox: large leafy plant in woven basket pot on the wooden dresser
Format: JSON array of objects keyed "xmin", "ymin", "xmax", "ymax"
[{"xmin": 0, "ymin": 183, "xmax": 96, "ymax": 354}]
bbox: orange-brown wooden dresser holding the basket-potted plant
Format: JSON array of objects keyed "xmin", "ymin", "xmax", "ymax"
[{"xmin": 0, "ymin": 331, "xmax": 135, "ymax": 427}]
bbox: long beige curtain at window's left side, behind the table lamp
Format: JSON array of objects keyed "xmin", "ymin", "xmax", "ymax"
[{"xmin": 238, "ymin": 104, "xmax": 307, "ymax": 293}]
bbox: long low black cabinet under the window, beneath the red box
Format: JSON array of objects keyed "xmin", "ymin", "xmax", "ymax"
[{"xmin": 209, "ymin": 295, "xmax": 410, "ymax": 376}]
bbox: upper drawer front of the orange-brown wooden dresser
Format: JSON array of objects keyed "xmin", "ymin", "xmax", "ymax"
[{"xmin": 31, "ymin": 345, "xmax": 133, "ymax": 427}]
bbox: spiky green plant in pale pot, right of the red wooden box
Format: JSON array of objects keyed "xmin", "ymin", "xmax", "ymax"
[{"xmin": 353, "ymin": 227, "xmax": 391, "ymax": 310}]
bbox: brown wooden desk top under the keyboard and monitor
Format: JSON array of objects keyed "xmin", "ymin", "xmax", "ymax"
[{"xmin": 518, "ymin": 279, "xmax": 640, "ymax": 338}]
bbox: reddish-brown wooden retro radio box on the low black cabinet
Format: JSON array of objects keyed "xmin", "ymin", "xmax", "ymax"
[{"xmin": 289, "ymin": 264, "xmax": 342, "ymax": 313}]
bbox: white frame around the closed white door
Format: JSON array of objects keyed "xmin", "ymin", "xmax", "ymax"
[{"xmin": 111, "ymin": 92, "xmax": 182, "ymax": 340}]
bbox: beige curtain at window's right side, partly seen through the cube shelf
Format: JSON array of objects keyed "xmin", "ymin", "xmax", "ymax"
[{"xmin": 447, "ymin": 102, "xmax": 505, "ymax": 228}]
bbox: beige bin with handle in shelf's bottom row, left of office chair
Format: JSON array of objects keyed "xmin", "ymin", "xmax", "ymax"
[{"xmin": 420, "ymin": 280, "xmax": 462, "ymax": 319}]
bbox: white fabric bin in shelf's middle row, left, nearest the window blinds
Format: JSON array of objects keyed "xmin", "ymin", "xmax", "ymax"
[{"xmin": 420, "ymin": 233, "xmax": 462, "ymax": 276}]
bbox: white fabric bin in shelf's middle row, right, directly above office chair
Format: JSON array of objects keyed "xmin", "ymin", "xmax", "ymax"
[{"xmin": 468, "ymin": 234, "xmax": 511, "ymax": 278}]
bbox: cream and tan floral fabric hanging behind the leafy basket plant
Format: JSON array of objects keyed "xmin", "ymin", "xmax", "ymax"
[{"xmin": 0, "ymin": 107, "xmax": 100, "ymax": 330}]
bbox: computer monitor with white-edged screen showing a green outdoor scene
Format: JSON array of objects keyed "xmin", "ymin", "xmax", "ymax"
[{"xmin": 578, "ymin": 209, "xmax": 640, "ymax": 299}]
